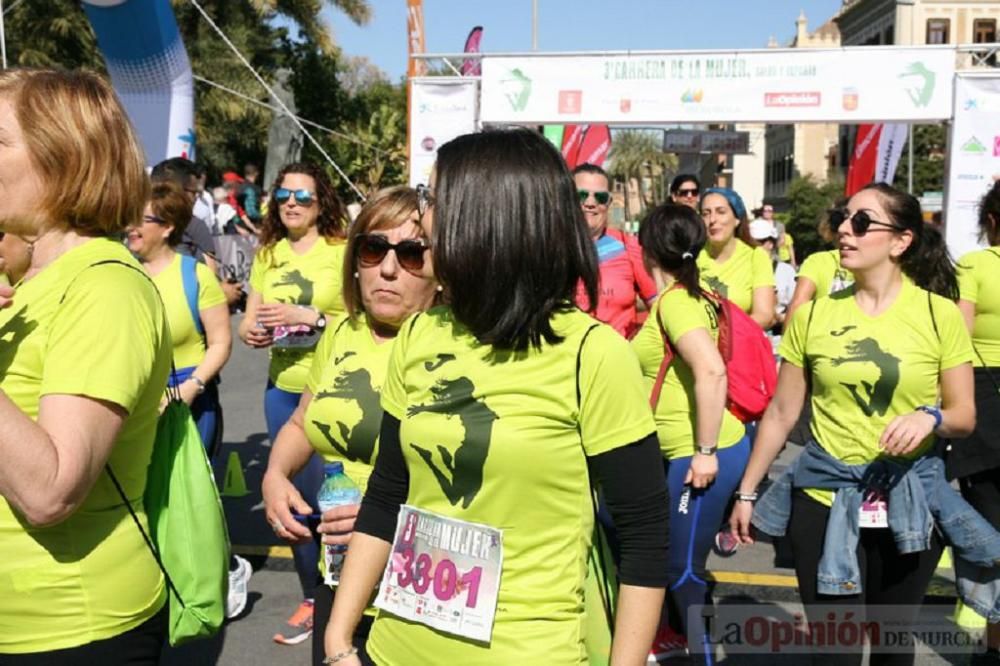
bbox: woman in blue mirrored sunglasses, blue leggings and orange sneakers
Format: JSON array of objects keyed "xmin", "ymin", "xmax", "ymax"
[{"xmin": 239, "ymin": 162, "xmax": 347, "ymax": 645}]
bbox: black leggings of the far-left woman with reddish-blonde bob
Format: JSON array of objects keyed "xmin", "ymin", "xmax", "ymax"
[{"xmin": 0, "ymin": 604, "xmax": 170, "ymax": 666}]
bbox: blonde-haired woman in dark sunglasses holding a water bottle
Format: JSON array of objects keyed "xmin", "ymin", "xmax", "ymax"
[{"xmin": 263, "ymin": 187, "xmax": 438, "ymax": 666}]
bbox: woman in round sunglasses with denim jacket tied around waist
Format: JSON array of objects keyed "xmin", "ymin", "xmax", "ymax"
[{"xmin": 732, "ymin": 184, "xmax": 975, "ymax": 663}]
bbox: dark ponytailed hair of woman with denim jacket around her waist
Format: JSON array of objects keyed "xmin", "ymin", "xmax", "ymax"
[{"xmin": 861, "ymin": 183, "xmax": 958, "ymax": 301}]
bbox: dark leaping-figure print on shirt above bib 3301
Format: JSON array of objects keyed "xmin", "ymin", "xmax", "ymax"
[{"xmin": 406, "ymin": 377, "xmax": 500, "ymax": 509}]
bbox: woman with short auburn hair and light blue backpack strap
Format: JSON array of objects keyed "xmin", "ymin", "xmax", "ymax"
[{"xmin": 128, "ymin": 182, "xmax": 232, "ymax": 457}]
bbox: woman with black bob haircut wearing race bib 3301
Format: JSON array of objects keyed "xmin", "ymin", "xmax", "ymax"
[{"xmin": 326, "ymin": 129, "xmax": 667, "ymax": 665}]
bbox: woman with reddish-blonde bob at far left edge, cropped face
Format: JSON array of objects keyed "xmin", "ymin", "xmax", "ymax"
[{"xmin": 0, "ymin": 69, "xmax": 170, "ymax": 666}]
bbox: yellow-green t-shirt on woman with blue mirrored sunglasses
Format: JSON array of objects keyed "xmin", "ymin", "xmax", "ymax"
[{"xmin": 250, "ymin": 237, "xmax": 346, "ymax": 393}]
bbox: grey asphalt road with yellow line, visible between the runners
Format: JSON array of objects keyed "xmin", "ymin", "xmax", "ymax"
[{"xmin": 165, "ymin": 318, "xmax": 968, "ymax": 666}]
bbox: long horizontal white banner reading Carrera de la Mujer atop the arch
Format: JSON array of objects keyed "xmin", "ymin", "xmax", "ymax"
[{"xmin": 480, "ymin": 46, "xmax": 955, "ymax": 124}]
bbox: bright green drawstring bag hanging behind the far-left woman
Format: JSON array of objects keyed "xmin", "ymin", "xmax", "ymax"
[{"xmin": 107, "ymin": 397, "xmax": 229, "ymax": 646}]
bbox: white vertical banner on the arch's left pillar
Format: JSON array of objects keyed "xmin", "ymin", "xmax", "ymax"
[{"xmin": 410, "ymin": 76, "xmax": 479, "ymax": 187}]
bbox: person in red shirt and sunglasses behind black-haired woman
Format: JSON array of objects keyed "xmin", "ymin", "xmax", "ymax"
[{"xmin": 573, "ymin": 164, "xmax": 656, "ymax": 338}]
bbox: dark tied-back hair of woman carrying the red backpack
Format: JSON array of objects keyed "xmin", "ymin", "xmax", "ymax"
[{"xmin": 639, "ymin": 204, "xmax": 707, "ymax": 298}]
